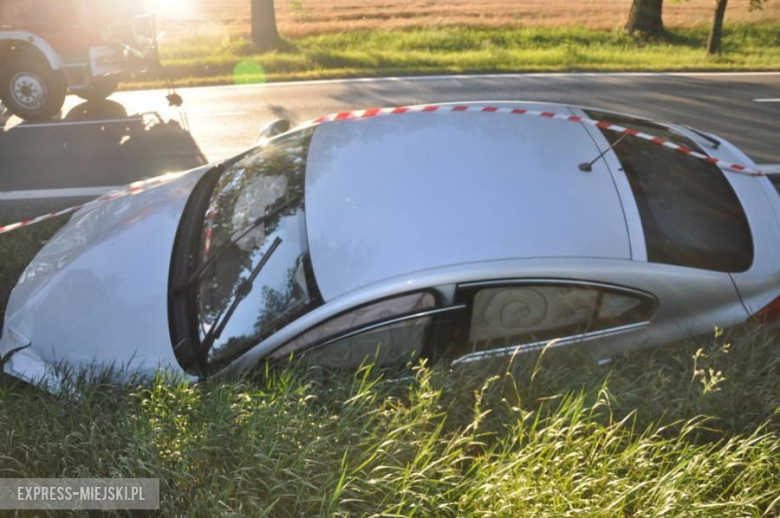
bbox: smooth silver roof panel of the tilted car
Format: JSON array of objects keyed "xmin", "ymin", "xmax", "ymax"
[{"xmin": 306, "ymin": 103, "xmax": 631, "ymax": 301}]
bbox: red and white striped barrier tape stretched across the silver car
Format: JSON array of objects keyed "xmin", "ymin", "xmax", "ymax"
[{"xmin": 0, "ymin": 105, "xmax": 765, "ymax": 234}]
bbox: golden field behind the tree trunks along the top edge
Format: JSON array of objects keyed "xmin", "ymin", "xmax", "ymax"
[{"xmin": 152, "ymin": 0, "xmax": 780, "ymax": 38}]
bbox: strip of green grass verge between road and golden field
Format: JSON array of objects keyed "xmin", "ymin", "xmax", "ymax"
[{"xmin": 126, "ymin": 24, "xmax": 780, "ymax": 87}]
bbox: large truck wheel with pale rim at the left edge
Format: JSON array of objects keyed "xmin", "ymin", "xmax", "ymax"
[{"xmin": 0, "ymin": 59, "xmax": 67, "ymax": 121}]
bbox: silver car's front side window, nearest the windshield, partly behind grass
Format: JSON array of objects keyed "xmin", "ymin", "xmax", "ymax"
[{"xmin": 269, "ymin": 292, "xmax": 436, "ymax": 368}]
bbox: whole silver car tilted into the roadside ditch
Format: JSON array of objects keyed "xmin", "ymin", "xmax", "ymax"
[{"xmin": 0, "ymin": 103, "xmax": 780, "ymax": 392}]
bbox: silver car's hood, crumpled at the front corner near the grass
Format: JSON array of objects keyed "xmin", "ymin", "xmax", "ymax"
[{"xmin": 0, "ymin": 167, "xmax": 208, "ymax": 390}]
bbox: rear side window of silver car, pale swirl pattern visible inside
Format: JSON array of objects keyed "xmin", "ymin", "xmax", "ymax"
[{"xmin": 449, "ymin": 283, "xmax": 655, "ymax": 357}]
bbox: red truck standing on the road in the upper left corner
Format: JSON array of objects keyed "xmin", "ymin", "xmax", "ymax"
[{"xmin": 0, "ymin": 0, "xmax": 159, "ymax": 121}]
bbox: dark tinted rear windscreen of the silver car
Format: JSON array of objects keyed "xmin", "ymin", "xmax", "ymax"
[{"xmin": 586, "ymin": 111, "xmax": 753, "ymax": 272}]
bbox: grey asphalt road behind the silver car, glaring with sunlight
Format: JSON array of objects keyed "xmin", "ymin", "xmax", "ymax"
[{"xmin": 0, "ymin": 73, "xmax": 780, "ymax": 201}]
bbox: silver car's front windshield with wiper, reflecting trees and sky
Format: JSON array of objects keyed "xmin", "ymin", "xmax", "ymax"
[{"xmin": 195, "ymin": 129, "xmax": 321, "ymax": 366}]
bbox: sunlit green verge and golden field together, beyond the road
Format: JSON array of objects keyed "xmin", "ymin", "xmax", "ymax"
[{"xmin": 108, "ymin": 0, "xmax": 780, "ymax": 88}]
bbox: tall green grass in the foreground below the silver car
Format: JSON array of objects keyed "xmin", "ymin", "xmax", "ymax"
[{"xmin": 0, "ymin": 333, "xmax": 780, "ymax": 516}]
